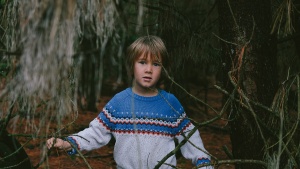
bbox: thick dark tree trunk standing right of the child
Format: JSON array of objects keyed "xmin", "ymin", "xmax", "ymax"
[{"xmin": 218, "ymin": 0, "xmax": 278, "ymax": 169}]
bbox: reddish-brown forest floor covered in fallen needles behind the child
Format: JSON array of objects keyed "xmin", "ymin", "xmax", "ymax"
[{"xmin": 12, "ymin": 82, "xmax": 234, "ymax": 169}]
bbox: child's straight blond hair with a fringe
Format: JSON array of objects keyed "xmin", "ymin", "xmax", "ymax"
[{"xmin": 126, "ymin": 35, "xmax": 169, "ymax": 85}]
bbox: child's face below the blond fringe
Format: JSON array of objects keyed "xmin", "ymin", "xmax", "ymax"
[{"xmin": 133, "ymin": 54, "xmax": 162, "ymax": 91}]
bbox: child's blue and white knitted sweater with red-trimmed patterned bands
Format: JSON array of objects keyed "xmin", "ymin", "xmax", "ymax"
[{"xmin": 68, "ymin": 88, "xmax": 212, "ymax": 169}]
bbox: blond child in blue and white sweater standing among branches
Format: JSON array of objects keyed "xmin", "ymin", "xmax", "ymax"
[{"xmin": 47, "ymin": 35, "xmax": 212, "ymax": 169}]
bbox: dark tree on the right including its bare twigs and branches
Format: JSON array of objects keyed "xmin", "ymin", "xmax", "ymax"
[{"xmin": 218, "ymin": 0, "xmax": 297, "ymax": 168}]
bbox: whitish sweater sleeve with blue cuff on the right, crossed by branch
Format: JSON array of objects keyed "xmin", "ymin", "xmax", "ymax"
[{"xmin": 176, "ymin": 122, "xmax": 213, "ymax": 169}]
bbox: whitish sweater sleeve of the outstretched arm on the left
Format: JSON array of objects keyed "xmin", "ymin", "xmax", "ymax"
[{"xmin": 66, "ymin": 111, "xmax": 112, "ymax": 155}]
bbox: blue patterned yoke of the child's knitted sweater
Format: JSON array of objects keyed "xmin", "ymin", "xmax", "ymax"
[{"xmin": 97, "ymin": 88, "xmax": 190, "ymax": 137}]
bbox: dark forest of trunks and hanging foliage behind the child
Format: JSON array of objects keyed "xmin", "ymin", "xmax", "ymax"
[{"xmin": 0, "ymin": 0, "xmax": 300, "ymax": 169}]
